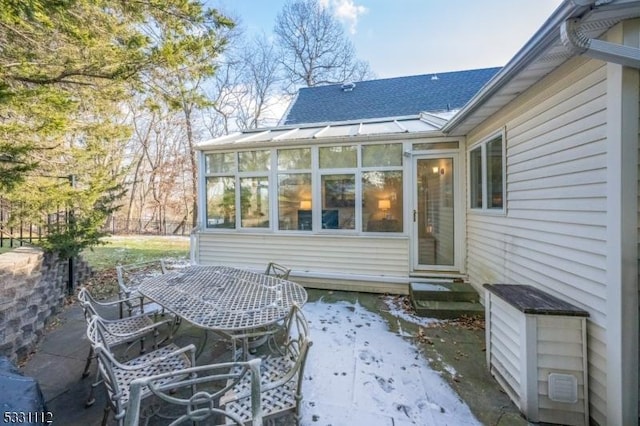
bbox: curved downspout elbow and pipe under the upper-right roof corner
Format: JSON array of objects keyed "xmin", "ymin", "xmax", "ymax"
[{"xmin": 560, "ymin": 19, "xmax": 640, "ymax": 68}]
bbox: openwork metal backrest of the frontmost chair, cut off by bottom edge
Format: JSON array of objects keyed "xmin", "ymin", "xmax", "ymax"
[{"xmin": 124, "ymin": 358, "xmax": 262, "ymax": 426}]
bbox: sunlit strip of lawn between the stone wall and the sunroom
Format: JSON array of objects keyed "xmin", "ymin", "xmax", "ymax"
[{"xmin": 82, "ymin": 235, "xmax": 189, "ymax": 271}]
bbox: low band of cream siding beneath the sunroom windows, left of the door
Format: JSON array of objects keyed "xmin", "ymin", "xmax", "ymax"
[{"xmin": 198, "ymin": 232, "xmax": 409, "ymax": 281}]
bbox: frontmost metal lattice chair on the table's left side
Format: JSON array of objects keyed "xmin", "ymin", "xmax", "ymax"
[{"xmin": 87, "ymin": 316, "xmax": 196, "ymax": 426}]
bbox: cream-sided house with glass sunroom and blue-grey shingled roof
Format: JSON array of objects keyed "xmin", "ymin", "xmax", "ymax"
[{"xmin": 194, "ymin": 0, "xmax": 640, "ymax": 425}]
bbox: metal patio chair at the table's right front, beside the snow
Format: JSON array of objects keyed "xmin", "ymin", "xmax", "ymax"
[{"xmin": 220, "ymin": 305, "xmax": 312, "ymax": 425}]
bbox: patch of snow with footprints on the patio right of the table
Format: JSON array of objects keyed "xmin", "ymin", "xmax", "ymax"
[{"xmin": 302, "ymin": 300, "xmax": 480, "ymax": 426}]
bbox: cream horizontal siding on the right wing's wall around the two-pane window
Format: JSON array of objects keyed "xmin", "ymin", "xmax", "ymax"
[{"xmin": 467, "ymin": 58, "xmax": 607, "ymax": 421}]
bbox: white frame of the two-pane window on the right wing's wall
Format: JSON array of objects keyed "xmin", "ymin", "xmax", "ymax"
[{"xmin": 467, "ymin": 129, "xmax": 507, "ymax": 215}]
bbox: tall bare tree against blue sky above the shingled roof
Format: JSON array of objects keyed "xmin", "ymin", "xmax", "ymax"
[{"xmin": 274, "ymin": 0, "xmax": 372, "ymax": 92}]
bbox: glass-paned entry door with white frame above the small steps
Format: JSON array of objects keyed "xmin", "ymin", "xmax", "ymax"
[{"xmin": 412, "ymin": 156, "xmax": 461, "ymax": 271}]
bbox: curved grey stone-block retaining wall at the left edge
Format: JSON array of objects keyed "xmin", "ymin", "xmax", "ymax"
[{"xmin": 0, "ymin": 247, "xmax": 91, "ymax": 362}]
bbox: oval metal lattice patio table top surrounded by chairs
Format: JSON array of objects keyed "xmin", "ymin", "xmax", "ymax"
[{"xmin": 138, "ymin": 266, "xmax": 307, "ymax": 358}]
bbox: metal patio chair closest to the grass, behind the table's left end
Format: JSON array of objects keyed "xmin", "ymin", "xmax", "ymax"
[{"xmin": 116, "ymin": 260, "xmax": 167, "ymax": 318}]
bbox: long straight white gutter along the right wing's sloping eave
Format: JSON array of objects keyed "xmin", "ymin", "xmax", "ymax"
[{"xmin": 442, "ymin": 0, "xmax": 596, "ymax": 133}]
